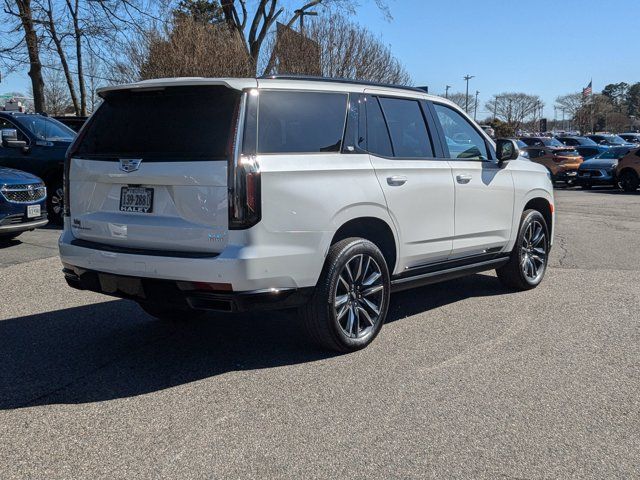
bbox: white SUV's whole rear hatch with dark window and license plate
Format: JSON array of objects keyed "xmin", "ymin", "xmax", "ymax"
[{"xmin": 68, "ymin": 85, "xmax": 241, "ymax": 254}]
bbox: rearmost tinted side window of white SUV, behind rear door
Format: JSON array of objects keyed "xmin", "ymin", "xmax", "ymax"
[{"xmin": 258, "ymin": 90, "xmax": 347, "ymax": 154}]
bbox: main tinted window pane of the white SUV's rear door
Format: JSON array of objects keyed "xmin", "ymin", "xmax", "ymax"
[{"xmin": 380, "ymin": 97, "xmax": 433, "ymax": 158}]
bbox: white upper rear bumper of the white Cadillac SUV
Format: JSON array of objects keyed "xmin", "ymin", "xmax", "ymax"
[{"xmin": 58, "ymin": 219, "xmax": 324, "ymax": 292}]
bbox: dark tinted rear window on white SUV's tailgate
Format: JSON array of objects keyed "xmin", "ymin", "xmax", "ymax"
[{"xmin": 73, "ymin": 86, "xmax": 240, "ymax": 160}]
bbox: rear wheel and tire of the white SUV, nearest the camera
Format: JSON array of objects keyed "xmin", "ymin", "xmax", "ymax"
[{"xmin": 301, "ymin": 238, "xmax": 390, "ymax": 352}]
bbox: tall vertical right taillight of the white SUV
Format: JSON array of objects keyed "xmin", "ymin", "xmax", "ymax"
[{"xmin": 229, "ymin": 90, "xmax": 261, "ymax": 230}]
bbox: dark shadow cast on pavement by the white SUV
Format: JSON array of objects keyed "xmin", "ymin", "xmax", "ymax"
[{"xmin": 0, "ymin": 275, "xmax": 505, "ymax": 410}]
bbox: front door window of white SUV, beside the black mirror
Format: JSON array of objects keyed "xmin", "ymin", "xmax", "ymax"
[{"xmin": 433, "ymin": 103, "xmax": 490, "ymax": 160}]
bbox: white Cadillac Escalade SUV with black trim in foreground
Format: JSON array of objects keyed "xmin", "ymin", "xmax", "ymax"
[{"xmin": 60, "ymin": 77, "xmax": 554, "ymax": 351}]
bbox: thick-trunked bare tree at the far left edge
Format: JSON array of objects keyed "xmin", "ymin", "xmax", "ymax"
[{"xmin": 0, "ymin": 0, "xmax": 44, "ymax": 112}]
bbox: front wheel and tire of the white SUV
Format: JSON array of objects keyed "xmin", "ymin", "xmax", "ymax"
[{"xmin": 496, "ymin": 210, "xmax": 549, "ymax": 291}]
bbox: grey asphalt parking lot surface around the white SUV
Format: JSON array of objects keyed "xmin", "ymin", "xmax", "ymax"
[{"xmin": 0, "ymin": 189, "xmax": 640, "ymax": 479}]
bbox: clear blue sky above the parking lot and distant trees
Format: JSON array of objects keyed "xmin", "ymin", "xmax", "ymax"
[{"xmin": 0, "ymin": 0, "xmax": 640, "ymax": 118}]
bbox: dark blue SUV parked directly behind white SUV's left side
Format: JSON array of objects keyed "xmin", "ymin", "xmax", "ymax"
[{"xmin": 0, "ymin": 112, "xmax": 75, "ymax": 225}]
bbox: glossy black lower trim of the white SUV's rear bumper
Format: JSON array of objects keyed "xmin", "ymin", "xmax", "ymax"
[{"xmin": 63, "ymin": 264, "xmax": 313, "ymax": 312}]
